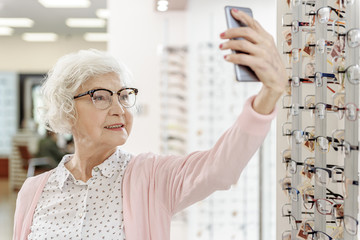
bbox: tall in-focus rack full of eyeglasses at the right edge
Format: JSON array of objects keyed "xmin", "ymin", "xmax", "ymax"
[{"xmin": 278, "ymin": 0, "xmax": 360, "ymax": 240}]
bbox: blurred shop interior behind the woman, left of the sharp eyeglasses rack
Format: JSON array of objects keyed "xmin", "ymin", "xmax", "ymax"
[{"xmin": 0, "ymin": 0, "xmax": 278, "ymax": 240}]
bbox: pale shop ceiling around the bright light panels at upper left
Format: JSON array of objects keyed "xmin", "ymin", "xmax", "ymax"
[{"xmin": 0, "ymin": 0, "xmax": 187, "ymax": 37}]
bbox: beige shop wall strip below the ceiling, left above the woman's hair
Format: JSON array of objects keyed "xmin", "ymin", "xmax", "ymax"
[{"xmin": 0, "ymin": 37, "xmax": 107, "ymax": 73}]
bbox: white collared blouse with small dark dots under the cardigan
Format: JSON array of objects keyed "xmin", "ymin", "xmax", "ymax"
[{"xmin": 28, "ymin": 148, "xmax": 131, "ymax": 240}]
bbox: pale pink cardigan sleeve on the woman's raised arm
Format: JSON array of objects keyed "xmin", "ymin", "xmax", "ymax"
[{"xmin": 139, "ymin": 94, "xmax": 276, "ymax": 215}]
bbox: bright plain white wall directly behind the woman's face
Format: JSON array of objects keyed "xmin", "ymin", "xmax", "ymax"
[{"xmin": 108, "ymin": 0, "xmax": 186, "ymax": 153}]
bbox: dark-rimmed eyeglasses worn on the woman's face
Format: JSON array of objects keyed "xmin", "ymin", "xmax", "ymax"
[{"xmin": 74, "ymin": 88, "xmax": 138, "ymax": 110}]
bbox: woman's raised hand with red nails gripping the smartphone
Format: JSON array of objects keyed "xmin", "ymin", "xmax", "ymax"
[{"xmin": 220, "ymin": 6, "xmax": 287, "ymax": 93}]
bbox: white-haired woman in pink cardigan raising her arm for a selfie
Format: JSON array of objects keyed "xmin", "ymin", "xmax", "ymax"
[{"xmin": 14, "ymin": 10, "xmax": 286, "ymax": 240}]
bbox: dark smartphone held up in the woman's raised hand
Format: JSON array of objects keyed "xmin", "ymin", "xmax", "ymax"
[{"xmin": 225, "ymin": 6, "xmax": 259, "ymax": 82}]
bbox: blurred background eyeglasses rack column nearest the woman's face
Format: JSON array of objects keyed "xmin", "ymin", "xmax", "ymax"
[{"xmin": 161, "ymin": 46, "xmax": 187, "ymax": 155}]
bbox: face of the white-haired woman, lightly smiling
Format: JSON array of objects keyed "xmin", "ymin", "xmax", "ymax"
[{"xmin": 72, "ymin": 73, "xmax": 133, "ymax": 149}]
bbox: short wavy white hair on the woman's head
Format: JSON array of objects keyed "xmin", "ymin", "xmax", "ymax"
[{"xmin": 39, "ymin": 49, "xmax": 132, "ymax": 133}]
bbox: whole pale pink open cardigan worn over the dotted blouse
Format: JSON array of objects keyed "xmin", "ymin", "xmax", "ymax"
[{"xmin": 13, "ymin": 97, "xmax": 276, "ymax": 240}]
